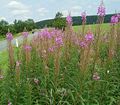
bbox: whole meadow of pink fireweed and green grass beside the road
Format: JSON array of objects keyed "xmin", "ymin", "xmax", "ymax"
[{"xmin": 0, "ymin": 2, "xmax": 120, "ymax": 105}]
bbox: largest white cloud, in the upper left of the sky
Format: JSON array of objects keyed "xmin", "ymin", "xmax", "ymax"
[{"xmin": 7, "ymin": 0, "xmax": 30, "ymax": 16}]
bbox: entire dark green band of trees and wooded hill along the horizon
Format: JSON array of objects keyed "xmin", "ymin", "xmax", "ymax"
[{"xmin": 0, "ymin": 12, "xmax": 114, "ymax": 37}]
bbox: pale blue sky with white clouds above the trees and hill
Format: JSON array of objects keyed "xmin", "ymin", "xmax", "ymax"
[{"xmin": 0, "ymin": 0, "xmax": 120, "ymax": 23}]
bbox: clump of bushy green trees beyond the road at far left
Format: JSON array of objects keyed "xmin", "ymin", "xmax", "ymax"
[{"xmin": 0, "ymin": 19, "xmax": 36, "ymax": 37}]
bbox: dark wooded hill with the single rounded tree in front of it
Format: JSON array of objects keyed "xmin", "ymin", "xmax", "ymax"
[{"xmin": 36, "ymin": 12, "xmax": 114, "ymax": 28}]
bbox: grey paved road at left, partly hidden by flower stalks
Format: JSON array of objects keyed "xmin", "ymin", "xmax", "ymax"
[{"xmin": 0, "ymin": 32, "xmax": 37, "ymax": 51}]
